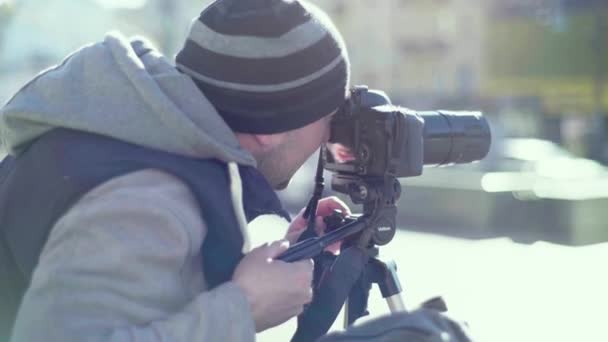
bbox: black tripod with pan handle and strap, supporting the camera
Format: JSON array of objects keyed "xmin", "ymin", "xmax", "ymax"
[{"xmin": 278, "ymin": 174, "xmax": 405, "ymax": 341}]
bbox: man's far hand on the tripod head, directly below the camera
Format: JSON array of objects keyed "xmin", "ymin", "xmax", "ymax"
[{"xmin": 285, "ymin": 196, "xmax": 351, "ymax": 254}]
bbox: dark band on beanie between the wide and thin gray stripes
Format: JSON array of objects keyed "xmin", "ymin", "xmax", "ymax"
[{"xmin": 175, "ymin": 34, "xmax": 342, "ymax": 85}]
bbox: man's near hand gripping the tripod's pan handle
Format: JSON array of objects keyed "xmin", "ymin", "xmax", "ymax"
[{"xmin": 232, "ymin": 240, "xmax": 314, "ymax": 332}]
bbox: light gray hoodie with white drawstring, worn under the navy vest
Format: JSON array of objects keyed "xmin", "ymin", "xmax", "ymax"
[{"xmin": 0, "ymin": 33, "xmax": 264, "ymax": 341}]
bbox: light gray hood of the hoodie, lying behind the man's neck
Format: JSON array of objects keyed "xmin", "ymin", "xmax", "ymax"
[{"xmin": 0, "ymin": 33, "xmax": 255, "ymax": 166}]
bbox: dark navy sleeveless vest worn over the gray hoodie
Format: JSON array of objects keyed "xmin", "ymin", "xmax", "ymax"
[{"xmin": 0, "ymin": 129, "xmax": 289, "ymax": 341}]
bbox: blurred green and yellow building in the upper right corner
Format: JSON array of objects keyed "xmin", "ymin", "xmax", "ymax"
[{"xmin": 485, "ymin": 0, "xmax": 608, "ymax": 115}]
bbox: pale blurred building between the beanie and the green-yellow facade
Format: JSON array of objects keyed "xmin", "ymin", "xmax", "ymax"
[{"xmin": 317, "ymin": 0, "xmax": 484, "ymax": 109}]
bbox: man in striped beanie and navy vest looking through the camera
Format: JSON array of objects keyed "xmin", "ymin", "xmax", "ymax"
[{"xmin": 0, "ymin": 0, "xmax": 349, "ymax": 341}]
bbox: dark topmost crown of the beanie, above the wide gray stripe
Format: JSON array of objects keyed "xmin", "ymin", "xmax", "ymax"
[{"xmin": 199, "ymin": 0, "xmax": 310, "ymax": 37}]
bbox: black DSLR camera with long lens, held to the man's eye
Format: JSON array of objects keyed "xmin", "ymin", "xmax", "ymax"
[{"xmin": 324, "ymin": 86, "xmax": 491, "ymax": 178}]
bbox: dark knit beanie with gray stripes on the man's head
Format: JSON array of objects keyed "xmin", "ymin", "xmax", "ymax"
[{"xmin": 176, "ymin": 0, "xmax": 350, "ymax": 134}]
